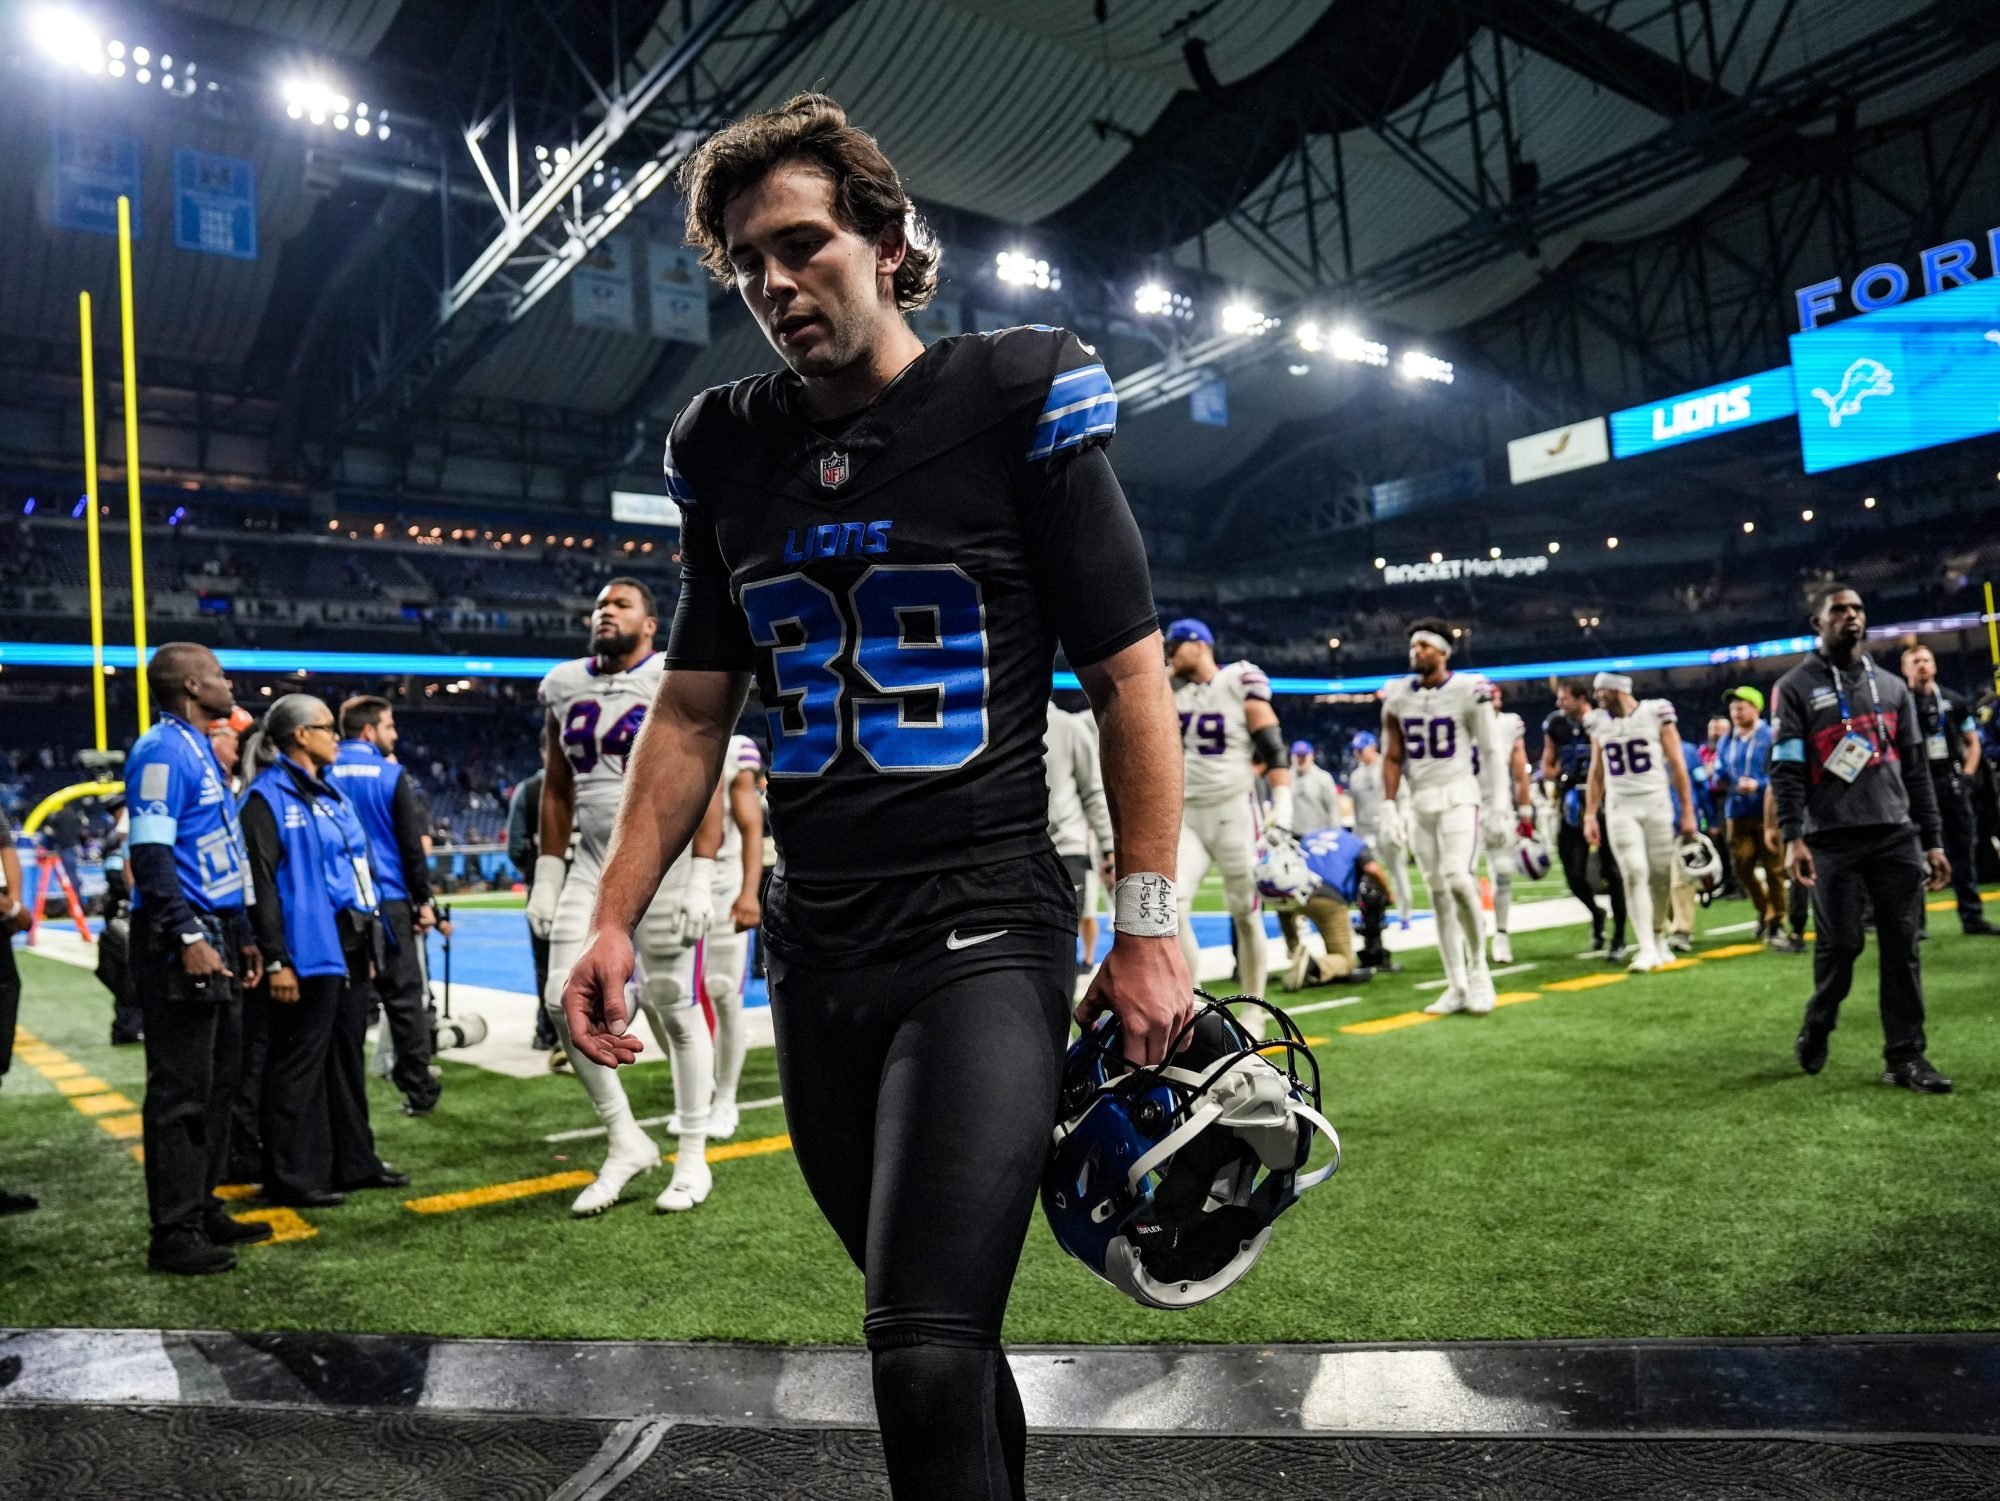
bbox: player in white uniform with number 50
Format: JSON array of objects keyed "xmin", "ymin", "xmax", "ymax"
[{"xmin": 1376, "ymin": 620, "xmax": 1500, "ymax": 1017}]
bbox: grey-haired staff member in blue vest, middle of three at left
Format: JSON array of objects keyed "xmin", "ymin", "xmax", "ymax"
[{"xmin": 242, "ymin": 692, "xmax": 410, "ymax": 1209}]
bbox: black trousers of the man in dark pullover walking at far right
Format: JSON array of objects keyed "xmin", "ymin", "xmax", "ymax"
[{"xmin": 1806, "ymin": 825, "xmax": 1926, "ymax": 1063}]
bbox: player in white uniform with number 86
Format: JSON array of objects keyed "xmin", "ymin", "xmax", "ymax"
[{"xmin": 1584, "ymin": 672, "xmax": 1694, "ymax": 973}]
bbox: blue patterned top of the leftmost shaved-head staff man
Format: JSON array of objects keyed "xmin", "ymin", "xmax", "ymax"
[{"xmin": 124, "ymin": 714, "xmax": 248, "ymax": 913}]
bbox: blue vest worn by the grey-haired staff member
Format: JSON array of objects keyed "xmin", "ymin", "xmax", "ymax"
[{"xmin": 244, "ymin": 761, "xmax": 376, "ymax": 979}]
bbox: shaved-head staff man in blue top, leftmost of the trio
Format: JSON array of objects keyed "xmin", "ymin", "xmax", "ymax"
[{"xmin": 124, "ymin": 640, "xmax": 270, "ymax": 1277}]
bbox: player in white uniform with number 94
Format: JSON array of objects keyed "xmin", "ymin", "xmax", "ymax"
[{"xmin": 528, "ymin": 578, "xmax": 722, "ymax": 1215}]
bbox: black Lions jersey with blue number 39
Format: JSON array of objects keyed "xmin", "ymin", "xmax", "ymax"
[{"xmin": 666, "ymin": 328, "xmax": 1158, "ymax": 955}]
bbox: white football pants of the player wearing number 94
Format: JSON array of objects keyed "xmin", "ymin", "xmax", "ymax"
[{"xmin": 542, "ymin": 853, "xmax": 716, "ymax": 1159}]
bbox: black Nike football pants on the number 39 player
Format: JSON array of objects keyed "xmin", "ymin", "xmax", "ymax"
[{"xmin": 766, "ymin": 929, "xmax": 1076, "ymax": 1501}]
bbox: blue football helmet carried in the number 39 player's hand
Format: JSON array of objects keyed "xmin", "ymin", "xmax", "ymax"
[{"xmin": 1042, "ymin": 1004, "xmax": 1340, "ymax": 1309}]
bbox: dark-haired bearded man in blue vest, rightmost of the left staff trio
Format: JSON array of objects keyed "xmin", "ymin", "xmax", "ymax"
[{"xmin": 326, "ymin": 694, "xmax": 438, "ymax": 1115}]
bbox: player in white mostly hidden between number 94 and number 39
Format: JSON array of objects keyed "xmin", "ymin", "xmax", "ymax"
[{"xmin": 666, "ymin": 734, "xmax": 764, "ymax": 1141}]
